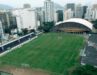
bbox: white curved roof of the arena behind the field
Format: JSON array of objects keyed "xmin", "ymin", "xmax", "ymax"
[{"xmin": 56, "ymin": 18, "xmax": 93, "ymax": 30}]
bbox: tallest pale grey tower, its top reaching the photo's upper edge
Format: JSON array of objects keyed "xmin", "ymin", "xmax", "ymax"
[{"xmin": 44, "ymin": 0, "xmax": 54, "ymax": 22}]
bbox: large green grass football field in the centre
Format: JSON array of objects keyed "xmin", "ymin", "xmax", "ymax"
[{"xmin": 0, "ymin": 33, "xmax": 84, "ymax": 74}]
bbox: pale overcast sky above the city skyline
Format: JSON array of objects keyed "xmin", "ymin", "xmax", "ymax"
[{"xmin": 0, "ymin": 0, "xmax": 97, "ymax": 8}]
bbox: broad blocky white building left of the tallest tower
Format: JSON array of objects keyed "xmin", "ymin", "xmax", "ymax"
[{"xmin": 12, "ymin": 8, "xmax": 37, "ymax": 32}]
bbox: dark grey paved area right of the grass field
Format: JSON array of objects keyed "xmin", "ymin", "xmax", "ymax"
[{"xmin": 81, "ymin": 34, "xmax": 97, "ymax": 66}]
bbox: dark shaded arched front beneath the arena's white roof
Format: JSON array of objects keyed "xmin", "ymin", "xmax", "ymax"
[{"xmin": 52, "ymin": 22, "xmax": 91, "ymax": 33}]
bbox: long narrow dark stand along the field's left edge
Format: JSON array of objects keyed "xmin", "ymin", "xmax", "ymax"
[{"xmin": 0, "ymin": 33, "xmax": 36, "ymax": 53}]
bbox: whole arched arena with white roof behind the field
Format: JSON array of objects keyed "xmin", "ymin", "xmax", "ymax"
[{"xmin": 53, "ymin": 18, "xmax": 93, "ymax": 33}]
